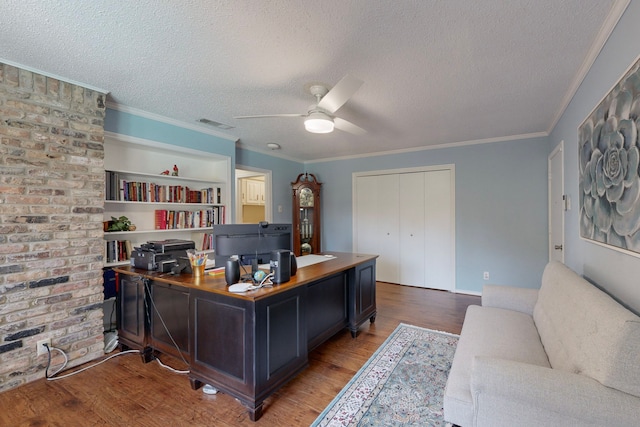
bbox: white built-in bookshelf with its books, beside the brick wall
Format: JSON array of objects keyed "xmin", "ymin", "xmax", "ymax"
[{"xmin": 104, "ymin": 132, "xmax": 231, "ymax": 267}]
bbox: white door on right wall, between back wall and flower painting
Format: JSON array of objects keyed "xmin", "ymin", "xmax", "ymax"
[{"xmin": 547, "ymin": 141, "xmax": 569, "ymax": 263}]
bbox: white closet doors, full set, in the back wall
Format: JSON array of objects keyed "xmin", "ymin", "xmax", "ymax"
[{"xmin": 354, "ymin": 165, "xmax": 455, "ymax": 290}]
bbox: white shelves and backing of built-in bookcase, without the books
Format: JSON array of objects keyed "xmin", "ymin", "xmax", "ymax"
[{"xmin": 104, "ymin": 132, "xmax": 231, "ymax": 267}]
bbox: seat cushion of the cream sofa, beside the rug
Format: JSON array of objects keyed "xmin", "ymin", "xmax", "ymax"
[{"xmin": 444, "ymin": 305, "xmax": 549, "ymax": 426}]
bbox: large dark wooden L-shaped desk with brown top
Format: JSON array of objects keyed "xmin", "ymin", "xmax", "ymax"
[{"xmin": 115, "ymin": 252, "xmax": 377, "ymax": 421}]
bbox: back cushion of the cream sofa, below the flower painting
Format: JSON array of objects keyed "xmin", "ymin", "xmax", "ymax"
[{"xmin": 533, "ymin": 262, "xmax": 640, "ymax": 397}]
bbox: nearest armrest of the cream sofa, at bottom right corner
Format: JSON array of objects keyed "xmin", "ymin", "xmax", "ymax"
[{"xmin": 471, "ymin": 357, "xmax": 640, "ymax": 427}]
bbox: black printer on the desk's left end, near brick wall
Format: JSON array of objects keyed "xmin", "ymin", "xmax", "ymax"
[{"xmin": 131, "ymin": 239, "xmax": 196, "ymax": 272}]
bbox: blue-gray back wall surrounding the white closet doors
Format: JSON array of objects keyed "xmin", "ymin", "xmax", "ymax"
[{"xmin": 307, "ymin": 138, "xmax": 548, "ymax": 293}]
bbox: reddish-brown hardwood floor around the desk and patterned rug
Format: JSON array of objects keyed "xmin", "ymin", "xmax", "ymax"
[{"xmin": 0, "ymin": 282, "xmax": 480, "ymax": 427}]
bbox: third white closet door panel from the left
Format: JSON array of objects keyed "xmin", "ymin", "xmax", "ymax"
[{"xmin": 399, "ymin": 172, "xmax": 425, "ymax": 286}]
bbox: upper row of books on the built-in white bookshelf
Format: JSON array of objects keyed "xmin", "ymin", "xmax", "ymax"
[{"xmin": 105, "ymin": 171, "xmax": 222, "ymax": 204}]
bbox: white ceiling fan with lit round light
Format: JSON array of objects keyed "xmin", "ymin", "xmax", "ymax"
[{"xmin": 234, "ymin": 74, "xmax": 367, "ymax": 135}]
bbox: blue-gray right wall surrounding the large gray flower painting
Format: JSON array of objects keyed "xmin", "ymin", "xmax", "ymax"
[{"xmin": 549, "ymin": 0, "xmax": 640, "ymax": 312}]
